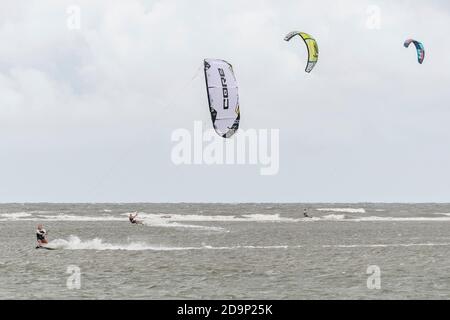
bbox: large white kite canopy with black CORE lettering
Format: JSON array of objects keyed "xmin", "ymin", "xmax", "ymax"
[{"xmin": 204, "ymin": 59, "xmax": 240, "ymax": 138}]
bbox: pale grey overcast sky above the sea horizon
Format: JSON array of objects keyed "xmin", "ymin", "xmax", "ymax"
[{"xmin": 0, "ymin": 0, "xmax": 450, "ymax": 202}]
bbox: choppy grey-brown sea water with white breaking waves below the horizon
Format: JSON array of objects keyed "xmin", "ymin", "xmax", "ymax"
[{"xmin": 0, "ymin": 203, "xmax": 450, "ymax": 299}]
